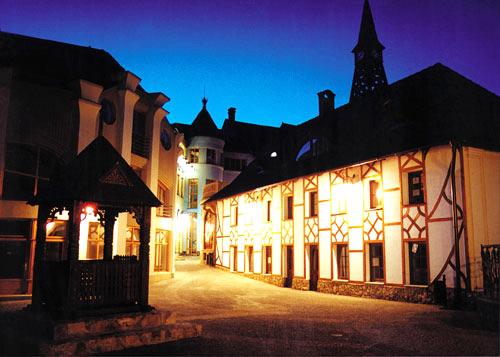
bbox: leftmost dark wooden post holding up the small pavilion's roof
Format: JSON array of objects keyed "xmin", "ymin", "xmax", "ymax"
[{"xmin": 31, "ymin": 204, "xmax": 49, "ymax": 312}]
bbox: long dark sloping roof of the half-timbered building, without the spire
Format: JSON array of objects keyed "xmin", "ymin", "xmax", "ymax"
[{"xmin": 207, "ymin": 63, "xmax": 500, "ymax": 202}]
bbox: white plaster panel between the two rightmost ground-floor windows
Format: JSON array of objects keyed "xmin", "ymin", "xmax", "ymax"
[{"xmin": 384, "ymin": 225, "xmax": 403, "ymax": 284}]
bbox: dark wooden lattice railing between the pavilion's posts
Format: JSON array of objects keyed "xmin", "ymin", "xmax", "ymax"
[{"xmin": 71, "ymin": 260, "xmax": 140, "ymax": 309}]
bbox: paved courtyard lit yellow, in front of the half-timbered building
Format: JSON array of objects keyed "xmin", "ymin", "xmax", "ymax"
[{"xmin": 0, "ymin": 258, "xmax": 500, "ymax": 356}]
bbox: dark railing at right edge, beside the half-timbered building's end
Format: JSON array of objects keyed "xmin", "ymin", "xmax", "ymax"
[{"xmin": 481, "ymin": 244, "xmax": 500, "ymax": 299}]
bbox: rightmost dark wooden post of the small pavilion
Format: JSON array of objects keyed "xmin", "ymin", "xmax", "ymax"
[{"xmin": 139, "ymin": 206, "xmax": 151, "ymax": 310}]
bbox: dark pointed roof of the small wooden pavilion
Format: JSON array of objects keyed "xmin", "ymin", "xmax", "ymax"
[{"xmin": 29, "ymin": 136, "xmax": 161, "ymax": 209}]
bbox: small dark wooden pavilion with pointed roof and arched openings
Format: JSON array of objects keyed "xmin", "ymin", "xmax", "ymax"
[{"xmin": 29, "ymin": 136, "xmax": 161, "ymax": 318}]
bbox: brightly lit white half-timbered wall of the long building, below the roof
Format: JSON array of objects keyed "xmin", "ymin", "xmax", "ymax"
[{"xmin": 205, "ymin": 146, "xmax": 500, "ymax": 301}]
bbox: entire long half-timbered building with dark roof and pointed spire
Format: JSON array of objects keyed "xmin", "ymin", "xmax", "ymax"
[{"xmin": 204, "ymin": 1, "xmax": 500, "ymax": 302}]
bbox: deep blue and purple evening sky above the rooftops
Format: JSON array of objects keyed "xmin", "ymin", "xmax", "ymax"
[{"xmin": 0, "ymin": 0, "xmax": 500, "ymax": 127}]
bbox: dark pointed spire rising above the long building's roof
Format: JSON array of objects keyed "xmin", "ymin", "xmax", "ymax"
[{"xmin": 350, "ymin": 0, "xmax": 387, "ymax": 101}]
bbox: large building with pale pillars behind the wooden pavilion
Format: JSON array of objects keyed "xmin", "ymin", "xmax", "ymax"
[{"xmin": 0, "ymin": 33, "xmax": 182, "ymax": 293}]
